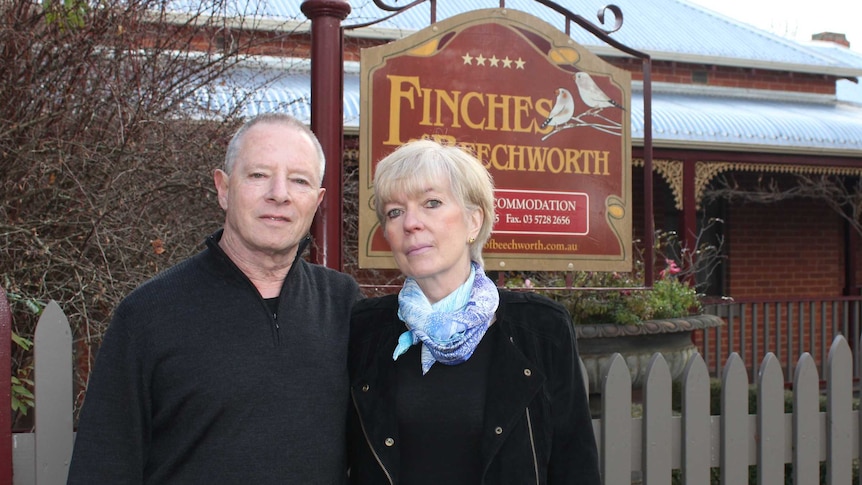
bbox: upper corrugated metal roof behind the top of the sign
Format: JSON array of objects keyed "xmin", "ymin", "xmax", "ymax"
[{"xmin": 197, "ymin": 0, "xmax": 862, "ymax": 76}]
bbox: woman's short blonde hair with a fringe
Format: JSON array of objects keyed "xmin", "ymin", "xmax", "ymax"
[{"xmin": 374, "ymin": 140, "xmax": 494, "ymax": 265}]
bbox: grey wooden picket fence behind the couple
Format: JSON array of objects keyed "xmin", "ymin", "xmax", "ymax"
[{"xmin": 6, "ymin": 302, "xmax": 860, "ymax": 485}]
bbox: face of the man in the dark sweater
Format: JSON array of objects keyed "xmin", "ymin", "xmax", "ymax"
[{"xmin": 215, "ymin": 123, "xmax": 326, "ymax": 263}]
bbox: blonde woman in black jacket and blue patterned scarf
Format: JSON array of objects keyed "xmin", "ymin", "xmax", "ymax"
[{"xmin": 349, "ymin": 140, "xmax": 600, "ymax": 485}]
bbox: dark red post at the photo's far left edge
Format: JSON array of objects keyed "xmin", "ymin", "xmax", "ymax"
[{"xmin": 0, "ymin": 288, "xmax": 12, "ymax": 483}]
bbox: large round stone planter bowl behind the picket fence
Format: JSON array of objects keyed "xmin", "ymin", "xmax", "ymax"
[{"xmin": 574, "ymin": 315, "xmax": 724, "ymax": 393}]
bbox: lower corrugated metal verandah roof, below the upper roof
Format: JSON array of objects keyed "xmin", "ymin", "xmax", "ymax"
[{"xmin": 206, "ymin": 64, "xmax": 862, "ymax": 157}]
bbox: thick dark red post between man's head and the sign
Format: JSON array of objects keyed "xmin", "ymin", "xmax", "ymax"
[{"xmin": 300, "ymin": 0, "xmax": 350, "ymax": 270}]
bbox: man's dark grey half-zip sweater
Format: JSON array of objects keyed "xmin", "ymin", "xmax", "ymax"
[{"xmin": 68, "ymin": 232, "xmax": 359, "ymax": 485}]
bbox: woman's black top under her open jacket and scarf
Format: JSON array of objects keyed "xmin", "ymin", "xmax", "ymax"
[{"xmin": 395, "ymin": 325, "xmax": 496, "ymax": 485}]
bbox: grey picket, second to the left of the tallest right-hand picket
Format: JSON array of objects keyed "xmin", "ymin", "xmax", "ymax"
[{"xmin": 757, "ymin": 352, "xmax": 786, "ymax": 485}]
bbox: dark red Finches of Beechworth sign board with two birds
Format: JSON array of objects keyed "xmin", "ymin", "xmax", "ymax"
[{"xmin": 359, "ymin": 9, "xmax": 632, "ymax": 271}]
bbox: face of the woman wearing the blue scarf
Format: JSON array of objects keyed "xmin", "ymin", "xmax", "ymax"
[{"xmin": 383, "ymin": 180, "xmax": 482, "ymax": 303}]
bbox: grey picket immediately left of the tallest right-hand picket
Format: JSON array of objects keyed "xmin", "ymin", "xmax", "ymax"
[{"xmin": 793, "ymin": 352, "xmax": 820, "ymax": 485}]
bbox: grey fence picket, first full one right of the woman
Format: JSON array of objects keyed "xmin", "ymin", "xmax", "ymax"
[{"xmin": 599, "ymin": 353, "xmax": 632, "ymax": 484}]
